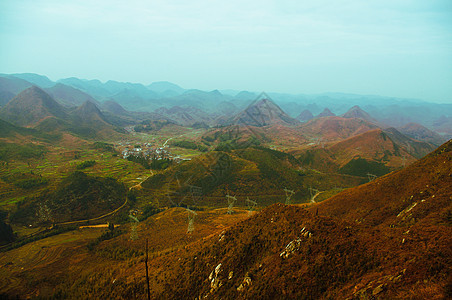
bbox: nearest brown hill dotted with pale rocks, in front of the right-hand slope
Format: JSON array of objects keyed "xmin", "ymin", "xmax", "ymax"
[{"xmin": 154, "ymin": 204, "xmax": 452, "ymax": 299}]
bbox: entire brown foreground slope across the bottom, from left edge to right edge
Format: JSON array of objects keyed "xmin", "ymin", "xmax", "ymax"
[{"xmin": 0, "ymin": 141, "xmax": 452, "ymax": 299}]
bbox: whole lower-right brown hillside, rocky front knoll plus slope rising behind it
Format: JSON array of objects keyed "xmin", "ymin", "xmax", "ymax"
[{"xmin": 149, "ymin": 142, "xmax": 452, "ymax": 299}]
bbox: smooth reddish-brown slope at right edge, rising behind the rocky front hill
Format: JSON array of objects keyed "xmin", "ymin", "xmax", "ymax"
[{"xmin": 315, "ymin": 141, "xmax": 452, "ymax": 226}]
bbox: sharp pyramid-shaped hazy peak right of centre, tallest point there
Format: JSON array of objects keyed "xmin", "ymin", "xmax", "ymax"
[{"xmin": 233, "ymin": 95, "xmax": 298, "ymax": 127}]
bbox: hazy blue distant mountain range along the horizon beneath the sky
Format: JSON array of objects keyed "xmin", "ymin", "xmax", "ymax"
[{"xmin": 0, "ymin": 73, "xmax": 452, "ymax": 139}]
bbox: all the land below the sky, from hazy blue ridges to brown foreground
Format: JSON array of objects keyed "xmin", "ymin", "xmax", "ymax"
[{"xmin": 0, "ymin": 74, "xmax": 452, "ymax": 299}]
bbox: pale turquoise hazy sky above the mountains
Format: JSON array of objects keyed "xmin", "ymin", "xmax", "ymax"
[{"xmin": 0, "ymin": 0, "xmax": 452, "ymax": 103}]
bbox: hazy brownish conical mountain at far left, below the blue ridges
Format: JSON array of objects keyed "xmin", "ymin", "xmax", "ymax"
[{"xmin": 0, "ymin": 86, "xmax": 67, "ymax": 126}]
